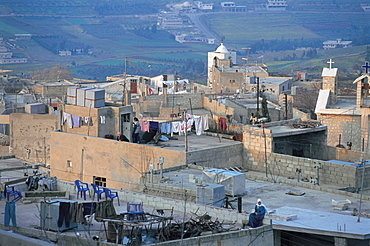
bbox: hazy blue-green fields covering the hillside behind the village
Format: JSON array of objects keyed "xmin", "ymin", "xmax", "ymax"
[{"xmin": 0, "ymin": 0, "xmax": 370, "ymax": 79}]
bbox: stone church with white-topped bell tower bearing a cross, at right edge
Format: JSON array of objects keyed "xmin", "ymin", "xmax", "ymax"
[{"xmin": 315, "ymin": 61, "xmax": 370, "ymax": 152}]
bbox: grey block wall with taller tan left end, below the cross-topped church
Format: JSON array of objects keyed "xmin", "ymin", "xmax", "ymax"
[{"xmin": 243, "ymin": 122, "xmax": 370, "ymax": 188}]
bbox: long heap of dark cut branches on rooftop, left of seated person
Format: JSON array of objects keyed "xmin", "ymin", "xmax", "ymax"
[{"xmin": 158, "ymin": 214, "xmax": 235, "ymax": 241}]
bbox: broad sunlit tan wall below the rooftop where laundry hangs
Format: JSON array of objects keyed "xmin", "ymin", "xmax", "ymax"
[{"xmin": 50, "ymin": 132, "xmax": 186, "ymax": 190}]
